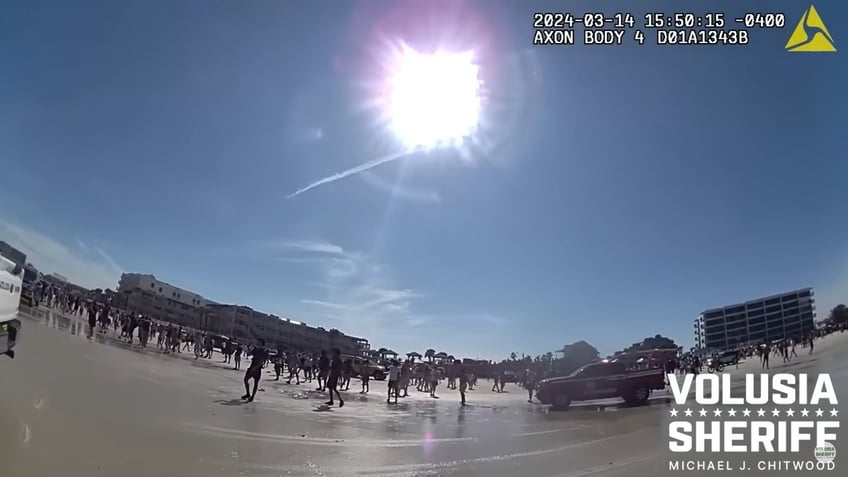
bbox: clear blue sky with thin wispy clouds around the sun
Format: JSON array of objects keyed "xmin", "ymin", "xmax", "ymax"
[{"xmin": 0, "ymin": 0, "xmax": 848, "ymax": 358}]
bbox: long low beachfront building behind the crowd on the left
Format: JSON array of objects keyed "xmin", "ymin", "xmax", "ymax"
[{"xmin": 117, "ymin": 273, "xmax": 370, "ymax": 355}]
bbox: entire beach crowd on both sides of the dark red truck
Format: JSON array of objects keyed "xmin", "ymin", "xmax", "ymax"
[{"xmin": 28, "ymin": 282, "xmax": 845, "ymax": 407}]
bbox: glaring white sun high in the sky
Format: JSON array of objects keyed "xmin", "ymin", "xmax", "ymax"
[{"xmin": 388, "ymin": 47, "xmax": 481, "ymax": 149}]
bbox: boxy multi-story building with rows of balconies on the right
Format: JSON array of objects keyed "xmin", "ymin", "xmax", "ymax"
[{"xmin": 694, "ymin": 288, "xmax": 816, "ymax": 350}]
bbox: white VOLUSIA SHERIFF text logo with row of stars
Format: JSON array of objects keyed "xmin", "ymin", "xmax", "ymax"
[{"xmin": 668, "ymin": 374, "xmax": 839, "ymax": 471}]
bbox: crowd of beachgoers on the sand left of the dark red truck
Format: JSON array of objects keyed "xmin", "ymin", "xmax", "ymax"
[{"xmin": 36, "ymin": 282, "xmax": 537, "ymax": 407}]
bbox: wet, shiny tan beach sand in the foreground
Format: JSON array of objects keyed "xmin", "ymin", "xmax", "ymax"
[{"xmin": 0, "ymin": 310, "xmax": 848, "ymax": 477}]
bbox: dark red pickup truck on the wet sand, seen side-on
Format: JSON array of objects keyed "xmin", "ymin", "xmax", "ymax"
[{"xmin": 536, "ymin": 360, "xmax": 665, "ymax": 409}]
